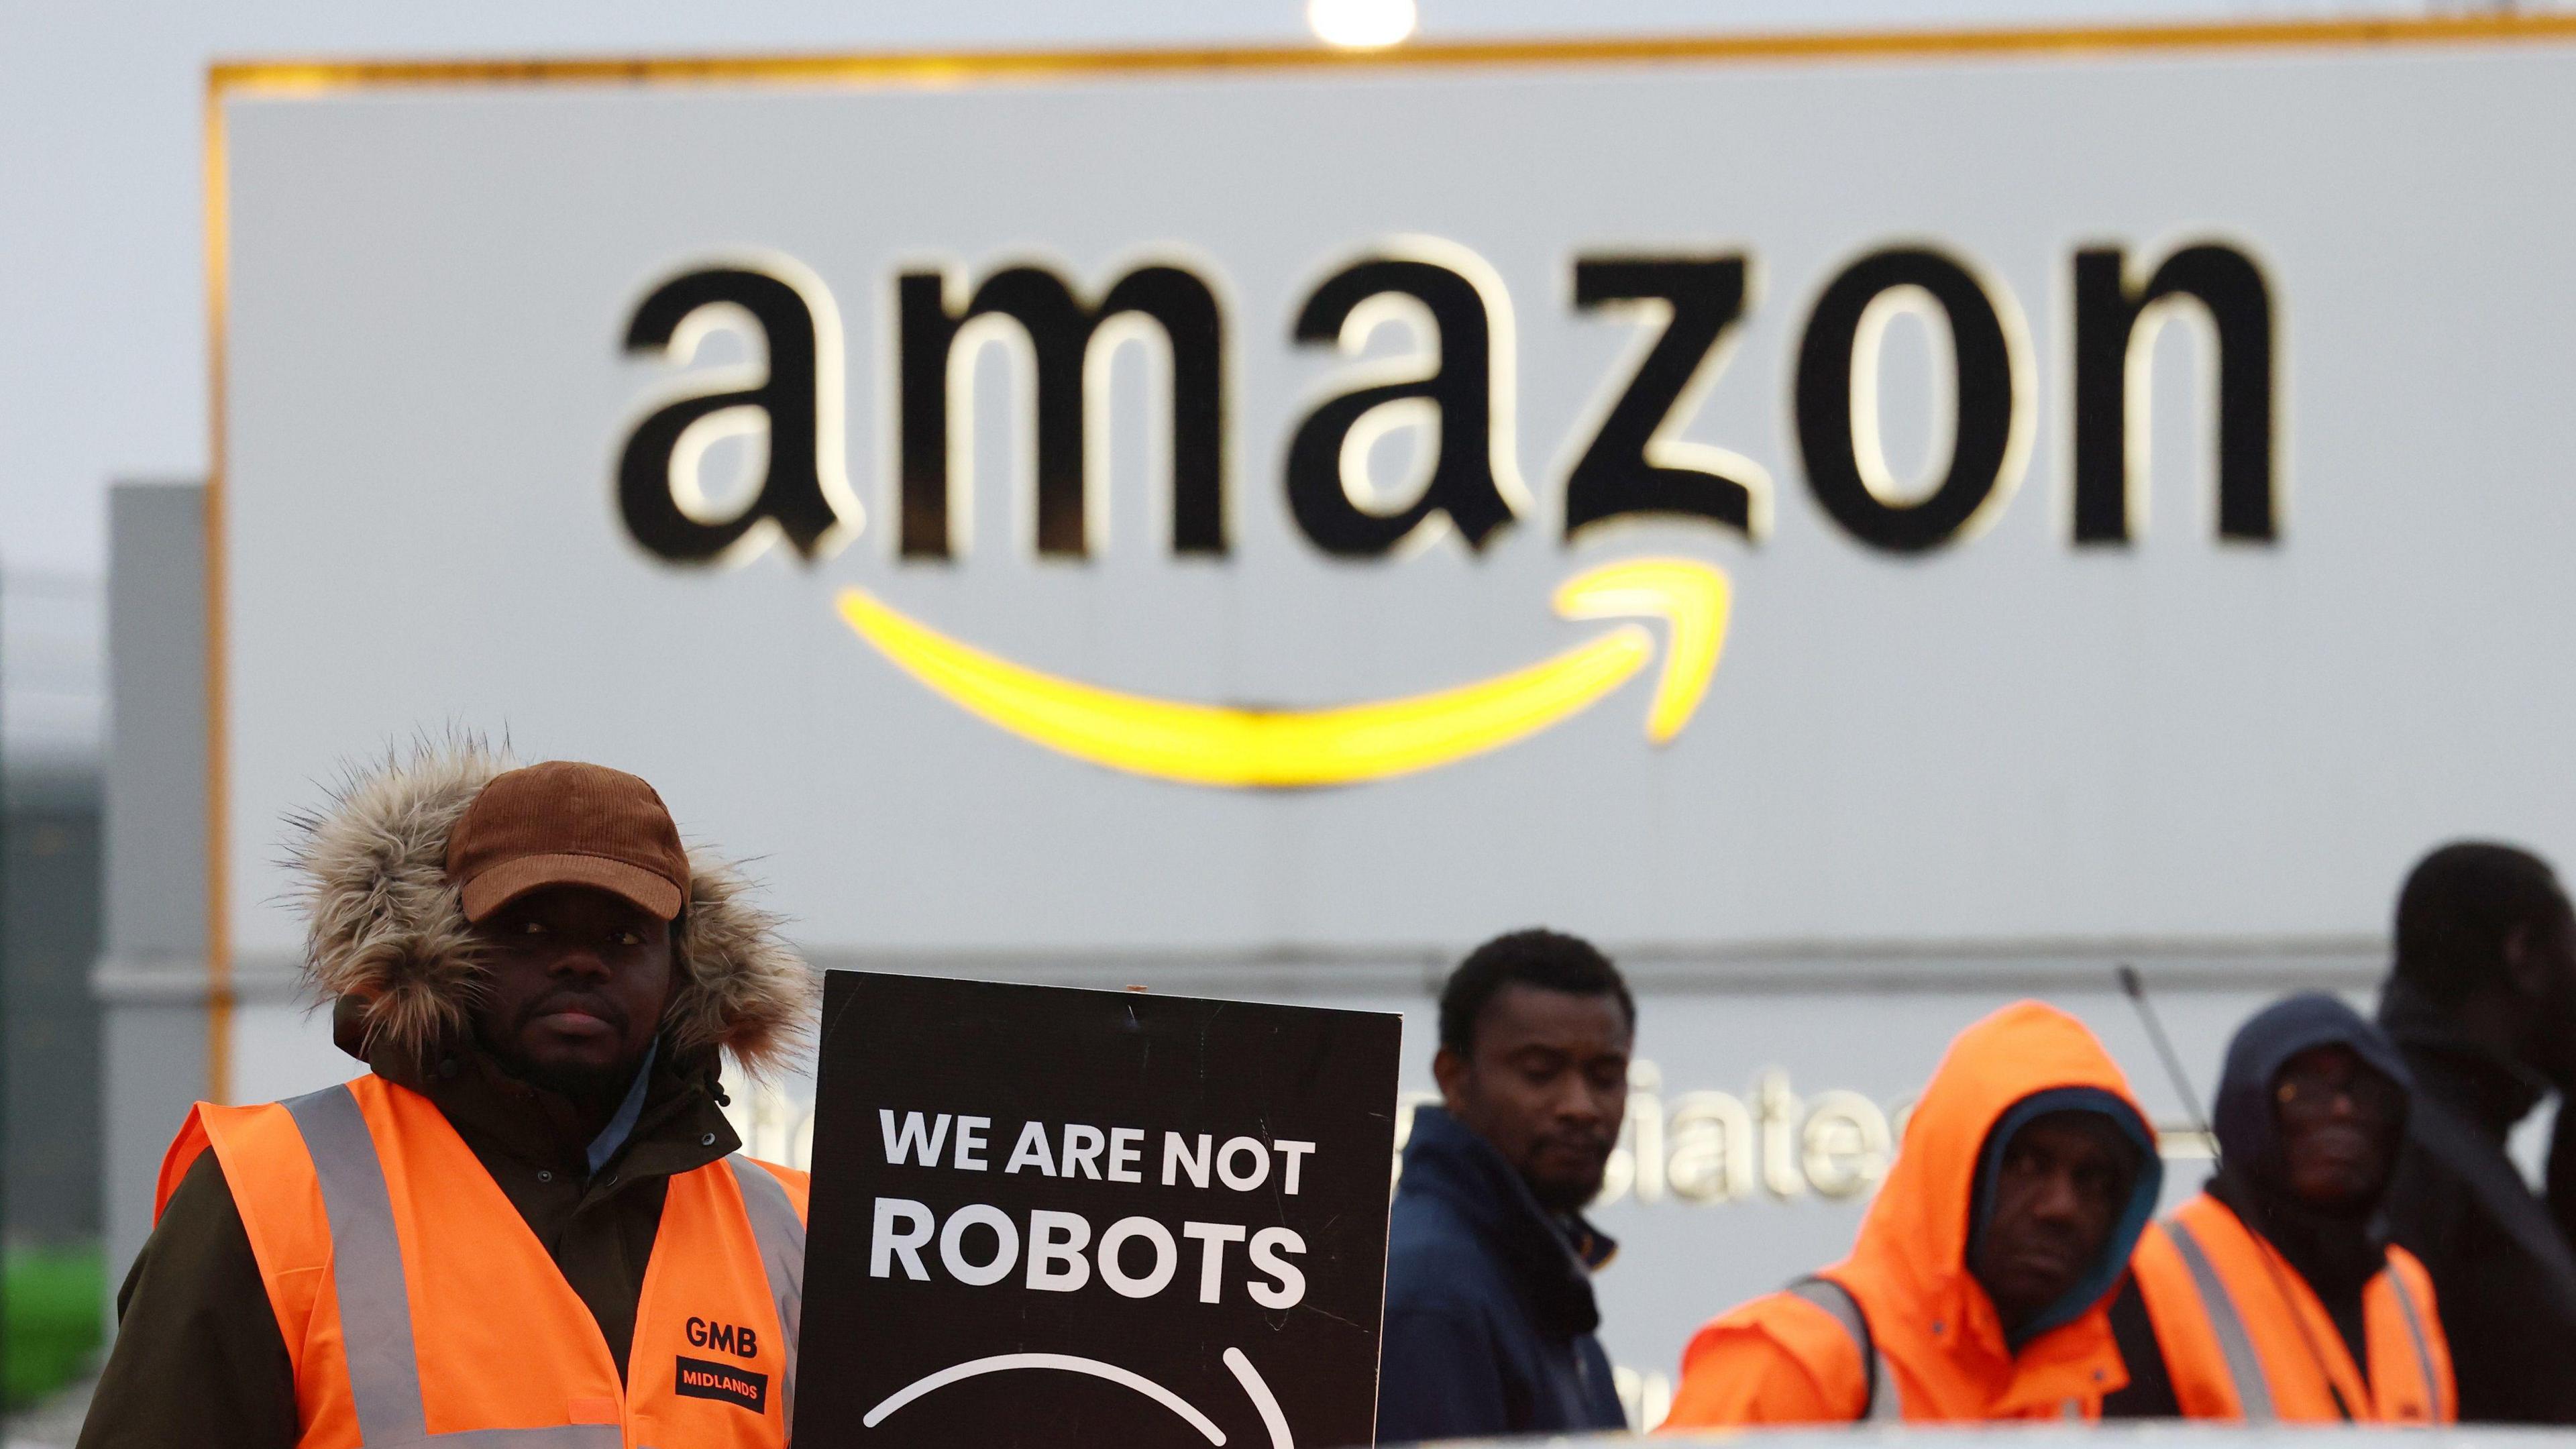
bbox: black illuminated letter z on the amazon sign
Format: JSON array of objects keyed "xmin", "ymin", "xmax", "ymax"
[{"xmin": 1566, "ymin": 255, "xmax": 1770, "ymax": 539}]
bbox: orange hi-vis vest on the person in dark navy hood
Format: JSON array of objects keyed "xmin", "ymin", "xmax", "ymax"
[{"xmin": 2131, "ymin": 1196, "xmax": 2460, "ymax": 1424}]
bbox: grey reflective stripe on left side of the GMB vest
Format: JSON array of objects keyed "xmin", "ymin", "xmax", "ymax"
[{"xmin": 281, "ymin": 1085, "xmax": 623, "ymax": 1449}]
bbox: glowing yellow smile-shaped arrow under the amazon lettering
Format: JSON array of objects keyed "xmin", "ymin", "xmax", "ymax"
[{"xmin": 840, "ymin": 559, "xmax": 1731, "ymax": 789}]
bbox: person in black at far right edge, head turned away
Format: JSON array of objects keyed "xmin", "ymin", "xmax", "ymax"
[{"xmin": 2380, "ymin": 841, "xmax": 2576, "ymax": 1424}]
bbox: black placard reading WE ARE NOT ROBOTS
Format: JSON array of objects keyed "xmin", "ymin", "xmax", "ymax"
[{"xmin": 794, "ymin": 972, "xmax": 1401, "ymax": 1449}]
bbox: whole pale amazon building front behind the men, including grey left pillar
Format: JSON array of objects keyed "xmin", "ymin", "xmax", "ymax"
[{"xmin": 101, "ymin": 18, "xmax": 2576, "ymax": 1418}]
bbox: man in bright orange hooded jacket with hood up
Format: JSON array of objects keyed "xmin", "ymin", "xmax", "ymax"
[{"xmin": 1664, "ymin": 1000, "xmax": 2164, "ymax": 1428}]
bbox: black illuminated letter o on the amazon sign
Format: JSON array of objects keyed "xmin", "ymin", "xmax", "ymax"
[{"xmin": 1795, "ymin": 248, "xmax": 2030, "ymax": 554}]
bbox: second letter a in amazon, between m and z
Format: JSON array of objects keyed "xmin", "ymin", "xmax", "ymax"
[{"xmin": 1288, "ymin": 239, "xmax": 1525, "ymax": 557}]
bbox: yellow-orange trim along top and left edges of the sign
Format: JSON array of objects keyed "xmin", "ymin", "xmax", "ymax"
[{"xmin": 206, "ymin": 13, "xmax": 2576, "ymax": 1101}]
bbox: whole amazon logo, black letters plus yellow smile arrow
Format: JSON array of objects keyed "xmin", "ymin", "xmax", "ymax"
[{"xmin": 616, "ymin": 237, "xmax": 2279, "ymax": 789}]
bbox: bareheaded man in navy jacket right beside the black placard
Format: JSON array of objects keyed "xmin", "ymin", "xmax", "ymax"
[{"xmin": 1378, "ymin": 930, "xmax": 1635, "ymax": 1444}]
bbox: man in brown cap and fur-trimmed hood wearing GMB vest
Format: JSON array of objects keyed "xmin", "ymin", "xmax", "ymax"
[{"xmin": 80, "ymin": 740, "xmax": 812, "ymax": 1449}]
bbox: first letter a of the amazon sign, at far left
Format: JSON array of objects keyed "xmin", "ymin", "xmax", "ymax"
[{"xmin": 619, "ymin": 258, "xmax": 861, "ymax": 565}]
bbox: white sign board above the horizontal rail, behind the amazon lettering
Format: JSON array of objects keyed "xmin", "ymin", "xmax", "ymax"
[{"xmin": 221, "ymin": 28, "xmax": 2576, "ymax": 954}]
